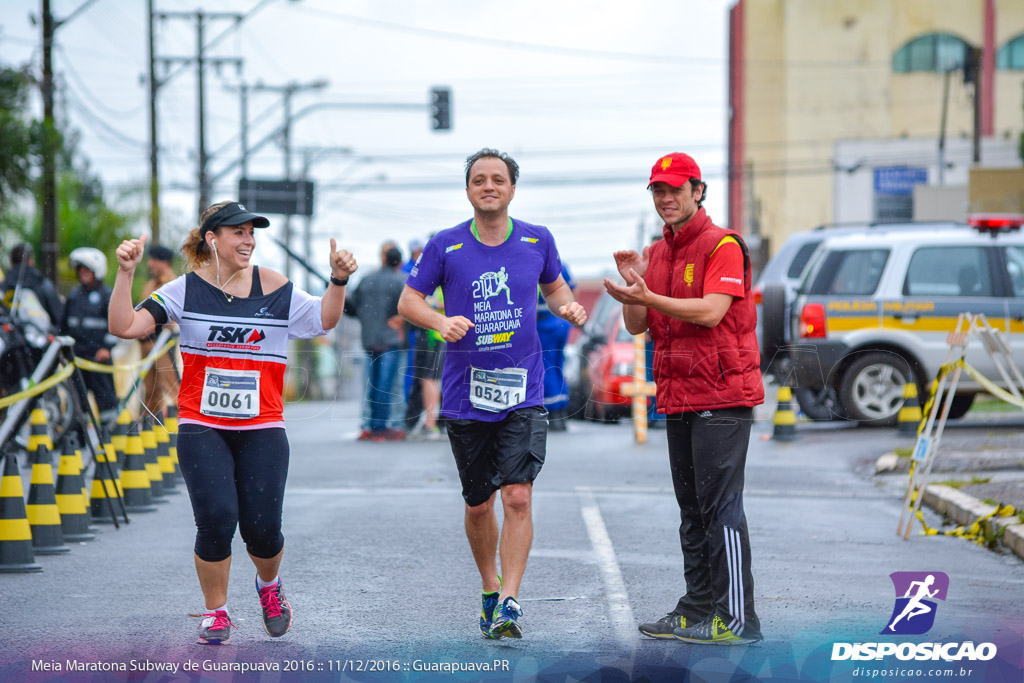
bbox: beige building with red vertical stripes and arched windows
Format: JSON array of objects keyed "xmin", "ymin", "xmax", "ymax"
[{"xmin": 729, "ymin": 0, "xmax": 1024, "ymax": 259}]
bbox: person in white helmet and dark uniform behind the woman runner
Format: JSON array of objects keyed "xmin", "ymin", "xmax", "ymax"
[{"xmin": 60, "ymin": 247, "xmax": 118, "ymax": 424}]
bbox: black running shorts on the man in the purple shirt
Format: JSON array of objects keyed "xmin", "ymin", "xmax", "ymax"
[{"xmin": 446, "ymin": 405, "xmax": 548, "ymax": 507}]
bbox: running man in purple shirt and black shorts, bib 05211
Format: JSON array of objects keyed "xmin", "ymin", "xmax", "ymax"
[{"xmin": 398, "ymin": 148, "xmax": 587, "ymax": 638}]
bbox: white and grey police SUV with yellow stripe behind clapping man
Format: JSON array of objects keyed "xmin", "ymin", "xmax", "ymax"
[{"xmin": 788, "ymin": 215, "xmax": 1024, "ymax": 425}]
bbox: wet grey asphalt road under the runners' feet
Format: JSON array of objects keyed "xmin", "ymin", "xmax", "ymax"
[{"xmin": 0, "ymin": 402, "xmax": 1024, "ymax": 681}]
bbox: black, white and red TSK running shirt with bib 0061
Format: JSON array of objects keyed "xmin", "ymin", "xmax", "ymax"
[{"xmin": 137, "ymin": 272, "xmax": 327, "ymax": 429}]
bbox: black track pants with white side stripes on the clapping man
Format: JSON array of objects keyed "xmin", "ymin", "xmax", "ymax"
[{"xmin": 667, "ymin": 408, "xmax": 761, "ymax": 637}]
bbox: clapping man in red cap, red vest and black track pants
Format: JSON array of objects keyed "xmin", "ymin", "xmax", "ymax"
[{"xmin": 604, "ymin": 154, "xmax": 764, "ymax": 644}]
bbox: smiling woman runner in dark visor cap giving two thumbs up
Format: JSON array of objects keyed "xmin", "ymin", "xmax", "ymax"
[{"xmin": 110, "ymin": 202, "xmax": 358, "ymax": 645}]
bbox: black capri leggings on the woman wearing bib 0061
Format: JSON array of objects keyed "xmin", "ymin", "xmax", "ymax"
[{"xmin": 178, "ymin": 424, "xmax": 289, "ymax": 562}]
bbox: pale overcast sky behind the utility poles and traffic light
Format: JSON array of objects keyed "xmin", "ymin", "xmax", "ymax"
[{"xmin": 0, "ymin": 0, "xmax": 729, "ymax": 283}]
